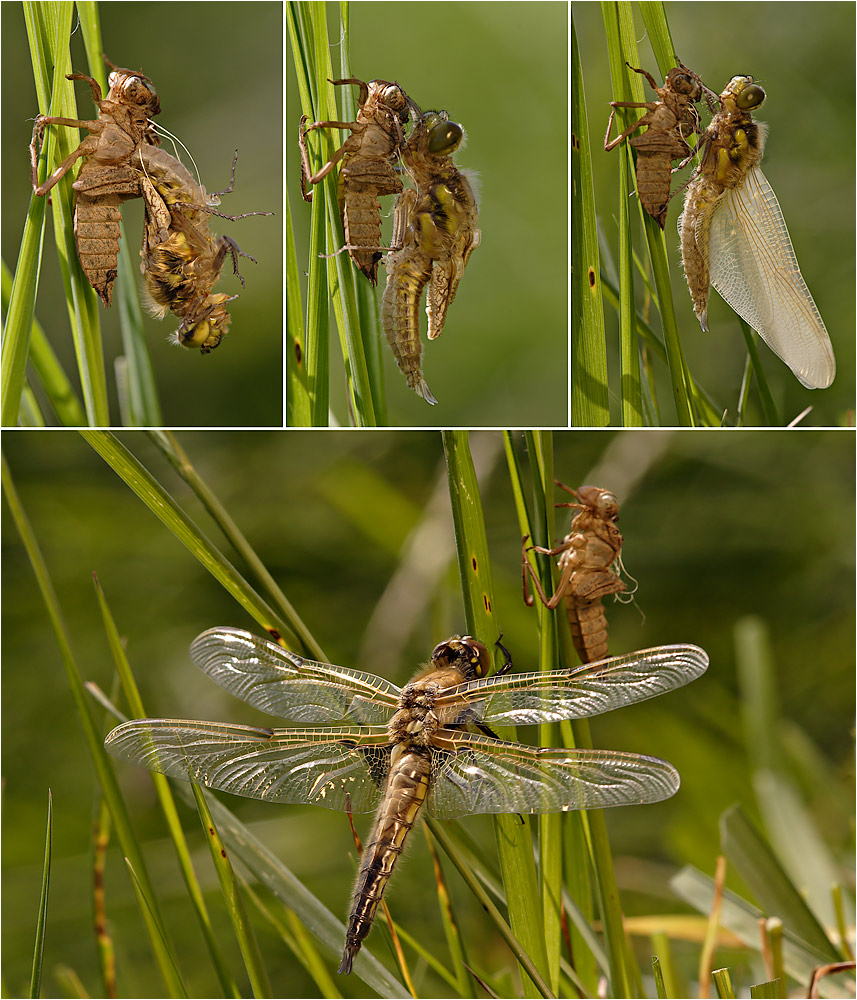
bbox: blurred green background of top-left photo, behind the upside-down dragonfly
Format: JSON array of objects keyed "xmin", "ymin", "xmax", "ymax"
[{"xmin": 0, "ymin": 3, "xmax": 283, "ymax": 427}]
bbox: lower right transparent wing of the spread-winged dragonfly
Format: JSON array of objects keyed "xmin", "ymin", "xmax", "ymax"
[{"xmin": 427, "ymin": 729, "xmax": 680, "ymax": 819}]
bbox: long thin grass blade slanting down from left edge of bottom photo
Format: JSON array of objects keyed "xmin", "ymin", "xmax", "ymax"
[{"xmin": 2, "ymin": 456, "xmax": 186, "ymax": 996}]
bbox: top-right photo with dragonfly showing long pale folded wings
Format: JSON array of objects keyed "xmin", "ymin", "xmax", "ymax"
[{"xmin": 571, "ymin": 2, "xmax": 857, "ymax": 427}]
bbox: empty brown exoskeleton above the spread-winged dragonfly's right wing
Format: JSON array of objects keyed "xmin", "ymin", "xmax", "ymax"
[{"xmin": 521, "ymin": 479, "xmax": 628, "ymax": 663}]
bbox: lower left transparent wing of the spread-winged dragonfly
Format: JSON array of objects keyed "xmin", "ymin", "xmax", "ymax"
[{"xmin": 104, "ymin": 719, "xmax": 392, "ymax": 812}]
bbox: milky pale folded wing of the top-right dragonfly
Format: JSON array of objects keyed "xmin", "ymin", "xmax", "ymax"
[{"xmin": 701, "ymin": 167, "xmax": 836, "ymax": 389}]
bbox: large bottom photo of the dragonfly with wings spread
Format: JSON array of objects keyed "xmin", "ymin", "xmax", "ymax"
[{"xmin": 0, "ymin": 430, "xmax": 855, "ymax": 997}]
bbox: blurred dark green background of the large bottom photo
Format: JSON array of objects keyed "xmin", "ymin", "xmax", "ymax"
[{"xmin": 2, "ymin": 431, "xmax": 855, "ymax": 996}]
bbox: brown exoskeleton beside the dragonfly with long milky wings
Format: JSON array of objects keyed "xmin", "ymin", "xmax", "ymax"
[{"xmin": 604, "ymin": 62, "xmax": 716, "ymax": 229}]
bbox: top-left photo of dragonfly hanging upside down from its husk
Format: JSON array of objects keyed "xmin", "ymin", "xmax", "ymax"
[{"xmin": 0, "ymin": 2, "xmax": 284, "ymax": 427}]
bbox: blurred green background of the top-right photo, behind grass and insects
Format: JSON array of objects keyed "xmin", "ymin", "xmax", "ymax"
[{"xmin": 572, "ymin": 3, "xmax": 855, "ymax": 426}]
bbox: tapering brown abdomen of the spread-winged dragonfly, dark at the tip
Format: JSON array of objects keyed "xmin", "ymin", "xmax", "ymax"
[{"xmin": 339, "ymin": 746, "xmax": 431, "ymax": 973}]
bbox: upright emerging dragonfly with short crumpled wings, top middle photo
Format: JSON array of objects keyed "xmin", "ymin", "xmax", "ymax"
[{"xmin": 381, "ymin": 111, "xmax": 481, "ymax": 403}]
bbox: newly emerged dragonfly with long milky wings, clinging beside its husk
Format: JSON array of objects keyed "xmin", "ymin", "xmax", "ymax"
[{"xmin": 678, "ymin": 76, "xmax": 836, "ymax": 389}]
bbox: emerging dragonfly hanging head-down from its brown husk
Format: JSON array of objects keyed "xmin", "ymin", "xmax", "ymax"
[{"xmin": 140, "ymin": 145, "xmax": 271, "ymax": 354}]
